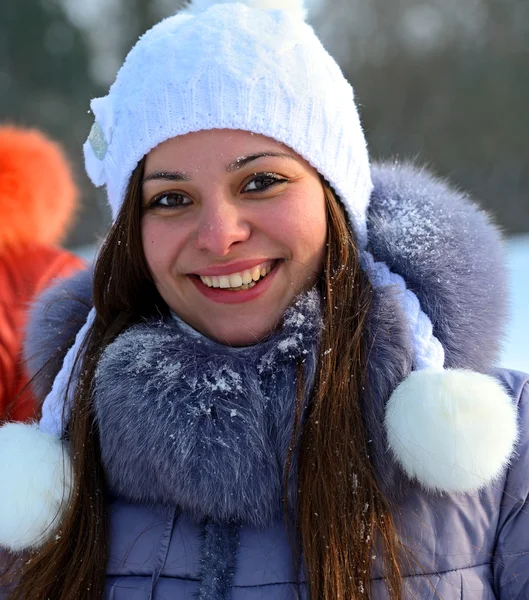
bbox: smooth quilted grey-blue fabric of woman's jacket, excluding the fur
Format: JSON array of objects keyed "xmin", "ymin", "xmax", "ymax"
[{"xmin": 103, "ymin": 371, "xmax": 529, "ymax": 600}]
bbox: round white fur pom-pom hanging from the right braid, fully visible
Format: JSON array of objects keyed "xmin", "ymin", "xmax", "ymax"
[{"xmin": 385, "ymin": 369, "xmax": 517, "ymax": 492}]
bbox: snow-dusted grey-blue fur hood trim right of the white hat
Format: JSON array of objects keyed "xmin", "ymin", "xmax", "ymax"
[{"xmin": 368, "ymin": 163, "xmax": 507, "ymax": 372}]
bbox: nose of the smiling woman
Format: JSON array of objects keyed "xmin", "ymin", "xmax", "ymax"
[{"xmin": 196, "ymin": 196, "xmax": 250, "ymax": 256}]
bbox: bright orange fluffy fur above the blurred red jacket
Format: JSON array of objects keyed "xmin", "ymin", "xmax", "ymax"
[{"xmin": 0, "ymin": 126, "xmax": 78, "ymax": 252}]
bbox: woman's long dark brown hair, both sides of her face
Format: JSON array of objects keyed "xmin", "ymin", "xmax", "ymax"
[{"xmin": 3, "ymin": 161, "xmax": 401, "ymax": 600}]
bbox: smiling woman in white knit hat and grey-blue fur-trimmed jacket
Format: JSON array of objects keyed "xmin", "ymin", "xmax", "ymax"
[{"xmin": 0, "ymin": 0, "xmax": 529, "ymax": 600}]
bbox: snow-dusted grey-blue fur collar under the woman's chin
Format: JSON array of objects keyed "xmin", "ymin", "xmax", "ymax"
[{"xmin": 94, "ymin": 291, "xmax": 321, "ymax": 526}]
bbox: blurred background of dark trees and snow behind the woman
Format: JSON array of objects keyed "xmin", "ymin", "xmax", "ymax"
[{"xmin": 0, "ymin": 0, "xmax": 529, "ymax": 371}]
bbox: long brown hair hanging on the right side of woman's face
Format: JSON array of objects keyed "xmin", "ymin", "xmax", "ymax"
[{"xmin": 285, "ymin": 185, "xmax": 402, "ymax": 600}]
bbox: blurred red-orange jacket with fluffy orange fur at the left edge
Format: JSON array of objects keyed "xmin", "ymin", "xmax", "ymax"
[{"xmin": 0, "ymin": 126, "xmax": 83, "ymax": 420}]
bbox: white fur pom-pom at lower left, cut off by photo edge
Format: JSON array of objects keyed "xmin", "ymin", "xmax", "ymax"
[{"xmin": 0, "ymin": 423, "xmax": 71, "ymax": 552}]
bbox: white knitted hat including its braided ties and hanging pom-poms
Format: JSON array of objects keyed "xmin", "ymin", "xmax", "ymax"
[{"xmin": 0, "ymin": 0, "xmax": 517, "ymax": 550}]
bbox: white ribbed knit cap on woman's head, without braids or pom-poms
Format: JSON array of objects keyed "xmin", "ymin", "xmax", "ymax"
[{"xmin": 84, "ymin": 0, "xmax": 372, "ymax": 247}]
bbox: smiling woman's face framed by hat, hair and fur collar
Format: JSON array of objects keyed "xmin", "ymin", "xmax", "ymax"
[{"xmin": 142, "ymin": 129, "xmax": 327, "ymax": 346}]
